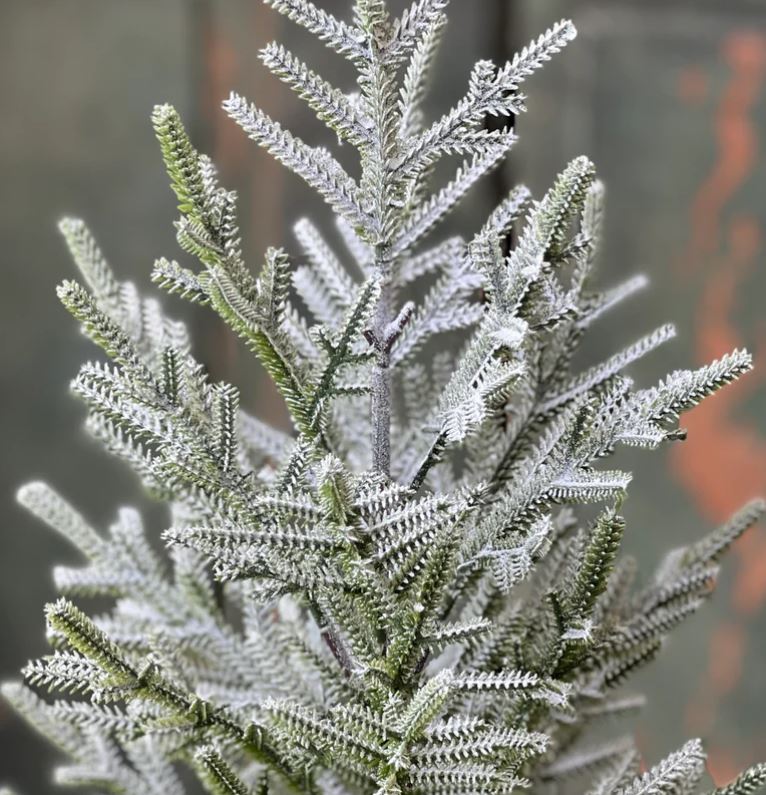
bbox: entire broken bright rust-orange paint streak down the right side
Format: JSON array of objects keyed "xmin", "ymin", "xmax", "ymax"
[{"xmin": 672, "ymin": 32, "xmax": 766, "ymax": 784}]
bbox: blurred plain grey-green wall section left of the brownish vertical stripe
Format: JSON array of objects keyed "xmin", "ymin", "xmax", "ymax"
[{"xmin": 0, "ymin": 0, "xmax": 191, "ymax": 794}]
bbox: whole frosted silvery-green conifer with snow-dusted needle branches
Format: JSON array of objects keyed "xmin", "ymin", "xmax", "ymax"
[{"xmin": 4, "ymin": 0, "xmax": 766, "ymax": 795}]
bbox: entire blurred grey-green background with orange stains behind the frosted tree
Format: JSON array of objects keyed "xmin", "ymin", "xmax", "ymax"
[{"xmin": 0, "ymin": 0, "xmax": 766, "ymax": 795}]
